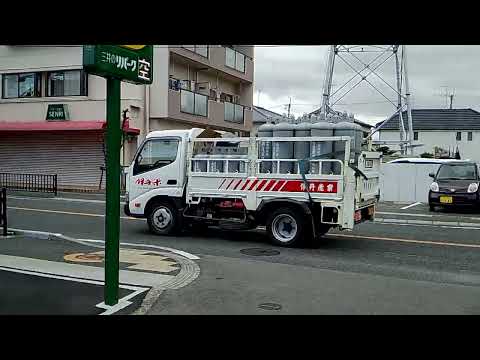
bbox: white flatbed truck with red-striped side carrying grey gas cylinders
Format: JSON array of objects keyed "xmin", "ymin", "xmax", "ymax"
[{"xmin": 124, "ymin": 128, "xmax": 381, "ymax": 246}]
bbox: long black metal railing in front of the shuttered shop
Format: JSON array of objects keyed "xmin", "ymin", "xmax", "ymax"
[{"xmin": 0, "ymin": 173, "xmax": 57, "ymax": 196}]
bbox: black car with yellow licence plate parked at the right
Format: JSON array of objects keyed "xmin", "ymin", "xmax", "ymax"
[{"xmin": 428, "ymin": 161, "xmax": 480, "ymax": 211}]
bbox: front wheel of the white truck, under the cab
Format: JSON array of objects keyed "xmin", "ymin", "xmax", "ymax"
[{"xmin": 147, "ymin": 202, "xmax": 179, "ymax": 235}]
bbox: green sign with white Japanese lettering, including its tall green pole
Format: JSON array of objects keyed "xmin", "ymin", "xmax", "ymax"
[{"xmin": 83, "ymin": 45, "xmax": 153, "ymax": 305}]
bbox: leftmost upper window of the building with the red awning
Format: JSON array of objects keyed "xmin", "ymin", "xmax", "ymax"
[{"xmin": 2, "ymin": 73, "xmax": 41, "ymax": 99}]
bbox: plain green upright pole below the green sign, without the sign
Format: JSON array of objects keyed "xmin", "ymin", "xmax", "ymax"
[{"xmin": 104, "ymin": 77, "xmax": 122, "ymax": 305}]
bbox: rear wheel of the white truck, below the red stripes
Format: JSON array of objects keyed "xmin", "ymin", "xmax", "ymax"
[{"xmin": 266, "ymin": 207, "xmax": 311, "ymax": 247}]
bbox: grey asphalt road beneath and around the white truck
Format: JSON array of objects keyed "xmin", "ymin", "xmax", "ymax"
[{"xmin": 3, "ymin": 194, "xmax": 480, "ymax": 314}]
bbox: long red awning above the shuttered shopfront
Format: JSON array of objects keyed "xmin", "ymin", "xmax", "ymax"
[{"xmin": 0, "ymin": 120, "xmax": 140, "ymax": 135}]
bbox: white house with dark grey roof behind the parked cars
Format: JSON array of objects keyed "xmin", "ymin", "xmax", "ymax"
[{"xmin": 377, "ymin": 109, "xmax": 480, "ymax": 162}]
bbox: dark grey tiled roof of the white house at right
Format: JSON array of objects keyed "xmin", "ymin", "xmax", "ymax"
[{"xmin": 376, "ymin": 109, "xmax": 480, "ymax": 130}]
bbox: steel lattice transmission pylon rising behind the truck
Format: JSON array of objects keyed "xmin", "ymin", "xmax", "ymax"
[{"xmin": 321, "ymin": 45, "xmax": 413, "ymax": 154}]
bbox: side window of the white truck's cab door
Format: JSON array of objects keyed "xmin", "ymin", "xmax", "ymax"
[{"xmin": 134, "ymin": 139, "xmax": 179, "ymax": 174}]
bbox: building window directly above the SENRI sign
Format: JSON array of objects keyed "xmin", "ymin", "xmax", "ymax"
[{"xmin": 47, "ymin": 70, "xmax": 87, "ymax": 96}]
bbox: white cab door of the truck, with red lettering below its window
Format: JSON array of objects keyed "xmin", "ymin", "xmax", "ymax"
[{"xmin": 128, "ymin": 137, "xmax": 185, "ymax": 201}]
